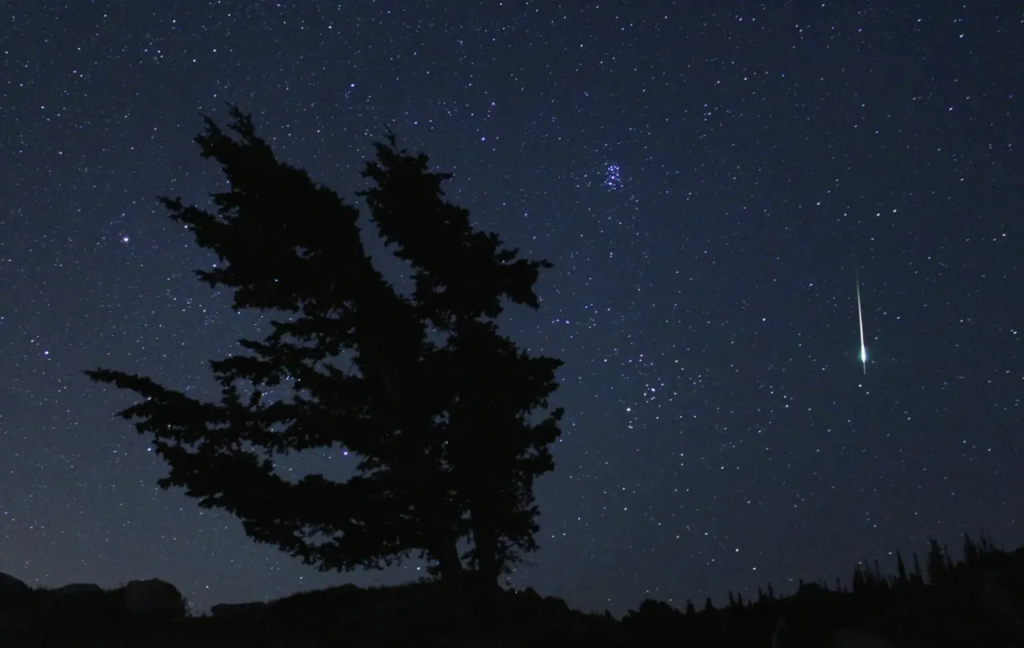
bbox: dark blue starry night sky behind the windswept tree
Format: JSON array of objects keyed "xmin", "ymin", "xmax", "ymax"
[{"xmin": 0, "ymin": 0, "xmax": 1024, "ymax": 614}]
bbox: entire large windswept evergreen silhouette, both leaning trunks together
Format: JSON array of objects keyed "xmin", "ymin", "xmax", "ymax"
[{"xmin": 86, "ymin": 105, "xmax": 562, "ymax": 587}]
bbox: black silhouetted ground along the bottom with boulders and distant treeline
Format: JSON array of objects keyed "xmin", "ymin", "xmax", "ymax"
[{"xmin": 0, "ymin": 541, "xmax": 1024, "ymax": 648}]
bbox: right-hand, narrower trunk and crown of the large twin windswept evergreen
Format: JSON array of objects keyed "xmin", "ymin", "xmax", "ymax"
[{"xmin": 359, "ymin": 117, "xmax": 562, "ymax": 582}]
